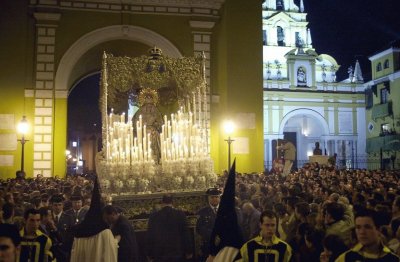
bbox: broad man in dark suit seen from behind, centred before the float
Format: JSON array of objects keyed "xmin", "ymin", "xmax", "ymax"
[{"xmin": 147, "ymin": 195, "xmax": 193, "ymax": 262}]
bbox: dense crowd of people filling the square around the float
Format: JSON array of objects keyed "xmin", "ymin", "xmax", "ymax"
[{"xmin": 0, "ymin": 163, "xmax": 400, "ymax": 262}]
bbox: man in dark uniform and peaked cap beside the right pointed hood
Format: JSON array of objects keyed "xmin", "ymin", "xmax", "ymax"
[{"xmin": 196, "ymin": 188, "xmax": 221, "ymax": 261}]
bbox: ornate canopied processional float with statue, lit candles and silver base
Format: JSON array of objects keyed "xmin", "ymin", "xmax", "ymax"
[{"xmin": 96, "ymin": 47, "xmax": 216, "ymax": 195}]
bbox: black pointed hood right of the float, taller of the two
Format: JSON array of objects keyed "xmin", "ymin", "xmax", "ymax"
[{"xmin": 210, "ymin": 159, "xmax": 243, "ymax": 256}]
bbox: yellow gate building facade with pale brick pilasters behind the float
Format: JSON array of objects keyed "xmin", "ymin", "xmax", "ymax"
[{"xmin": 0, "ymin": 0, "xmax": 264, "ymax": 178}]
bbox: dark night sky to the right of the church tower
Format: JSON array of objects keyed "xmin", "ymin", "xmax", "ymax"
[{"xmin": 304, "ymin": 0, "xmax": 400, "ymax": 81}]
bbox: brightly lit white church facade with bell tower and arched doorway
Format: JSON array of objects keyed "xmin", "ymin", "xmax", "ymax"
[{"xmin": 262, "ymin": 0, "xmax": 366, "ymax": 169}]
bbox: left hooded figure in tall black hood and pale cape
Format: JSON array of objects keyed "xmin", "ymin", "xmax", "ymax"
[{"xmin": 71, "ymin": 178, "xmax": 118, "ymax": 262}]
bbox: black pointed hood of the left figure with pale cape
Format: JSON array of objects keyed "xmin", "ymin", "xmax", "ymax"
[{"xmin": 73, "ymin": 177, "xmax": 109, "ymax": 238}]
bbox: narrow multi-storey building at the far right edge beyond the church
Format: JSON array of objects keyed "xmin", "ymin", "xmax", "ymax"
[{"xmin": 365, "ymin": 41, "xmax": 400, "ymax": 169}]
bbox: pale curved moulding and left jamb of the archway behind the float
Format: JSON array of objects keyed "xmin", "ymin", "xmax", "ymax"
[{"xmin": 52, "ymin": 25, "xmax": 182, "ymax": 175}]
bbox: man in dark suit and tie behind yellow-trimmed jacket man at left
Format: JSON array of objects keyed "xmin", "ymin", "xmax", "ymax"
[{"xmin": 50, "ymin": 195, "xmax": 74, "ymax": 261}]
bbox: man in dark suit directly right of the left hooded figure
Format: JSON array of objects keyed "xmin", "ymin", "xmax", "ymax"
[{"xmin": 103, "ymin": 205, "xmax": 139, "ymax": 262}]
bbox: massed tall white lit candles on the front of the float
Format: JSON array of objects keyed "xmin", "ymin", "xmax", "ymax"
[{"xmin": 106, "ymin": 109, "xmax": 209, "ymax": 164}]
